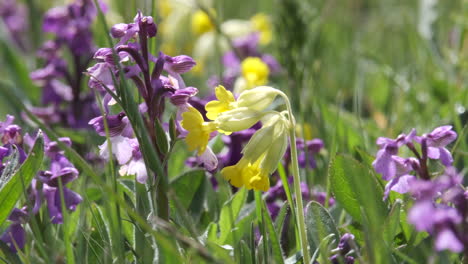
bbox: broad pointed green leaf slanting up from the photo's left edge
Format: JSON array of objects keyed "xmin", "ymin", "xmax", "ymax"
[{"xmin": 0, "ymin": 132, "xmax": 44, "ymax": 225}]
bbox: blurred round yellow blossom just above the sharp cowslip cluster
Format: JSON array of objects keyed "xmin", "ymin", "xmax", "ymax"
[{"xmin": 241, "ymin": 57, "xmax": 270, "ymax": 89}]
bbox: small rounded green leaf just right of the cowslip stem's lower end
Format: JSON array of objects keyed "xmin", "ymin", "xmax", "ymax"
[{"xmin": 306, "ymin": 202, "xmax": 340, "ymax": 252}]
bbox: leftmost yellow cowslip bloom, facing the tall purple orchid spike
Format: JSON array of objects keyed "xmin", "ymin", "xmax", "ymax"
[{"xmin": 181, "ymin": 107, "xmax": 217, "ymax": 155}]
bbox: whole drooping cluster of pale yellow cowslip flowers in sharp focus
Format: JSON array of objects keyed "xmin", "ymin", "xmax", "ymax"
[{"xmin": 182, "ymin": 86, "xmax": 290, "ymax": 191}]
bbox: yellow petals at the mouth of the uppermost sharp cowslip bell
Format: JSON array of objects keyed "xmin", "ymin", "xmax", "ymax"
[{"xmin": 205, "ymin": 85, "xmax": 237, "ymax": 120}]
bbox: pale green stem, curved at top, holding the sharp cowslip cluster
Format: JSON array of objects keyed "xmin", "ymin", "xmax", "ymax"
[{"xmin": 278, "ymin": 91, "xmax": 310, "ymax": 264}]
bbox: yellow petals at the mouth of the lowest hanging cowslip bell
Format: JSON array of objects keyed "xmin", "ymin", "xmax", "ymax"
[{"xmin": 221, "ymin": 159, "xmax": 270, "ymax": 192}]
